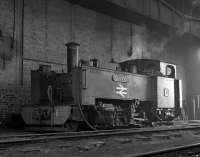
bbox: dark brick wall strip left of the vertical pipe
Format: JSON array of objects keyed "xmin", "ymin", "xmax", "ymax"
[{"xmin": 0, "ymin": 0, "xmax": 26, "ymax": 120}]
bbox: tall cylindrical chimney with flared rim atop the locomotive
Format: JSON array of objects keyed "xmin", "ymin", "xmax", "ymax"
[{"xmin": 65, "ymin": 42, "xmax": 80, "ymax": 72}]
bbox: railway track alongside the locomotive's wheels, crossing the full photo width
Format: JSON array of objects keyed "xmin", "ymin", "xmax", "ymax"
[{"xmin": 0, "ymin": 125, "xmax": 200, "ymax": 147}]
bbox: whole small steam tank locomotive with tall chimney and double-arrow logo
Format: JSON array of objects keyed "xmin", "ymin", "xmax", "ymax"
[{"xmin": 22, "ymin": 43, "xmax": 182, "ymax": 130}]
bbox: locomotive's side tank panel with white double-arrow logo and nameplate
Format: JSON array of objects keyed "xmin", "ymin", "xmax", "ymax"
[{"xmin": 77, "ymin": 67, "xmax": 151, "ymax": 105}]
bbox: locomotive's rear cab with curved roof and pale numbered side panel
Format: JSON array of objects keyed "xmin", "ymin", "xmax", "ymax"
[{"xmin": 120, "ymin": 59, "xmax": 182, "ymax": 121}]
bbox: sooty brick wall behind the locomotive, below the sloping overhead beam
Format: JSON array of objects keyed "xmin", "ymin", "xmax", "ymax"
[{"xmin": 0, "ymin": 0, "xmax": 195, "ymax": 119}]
